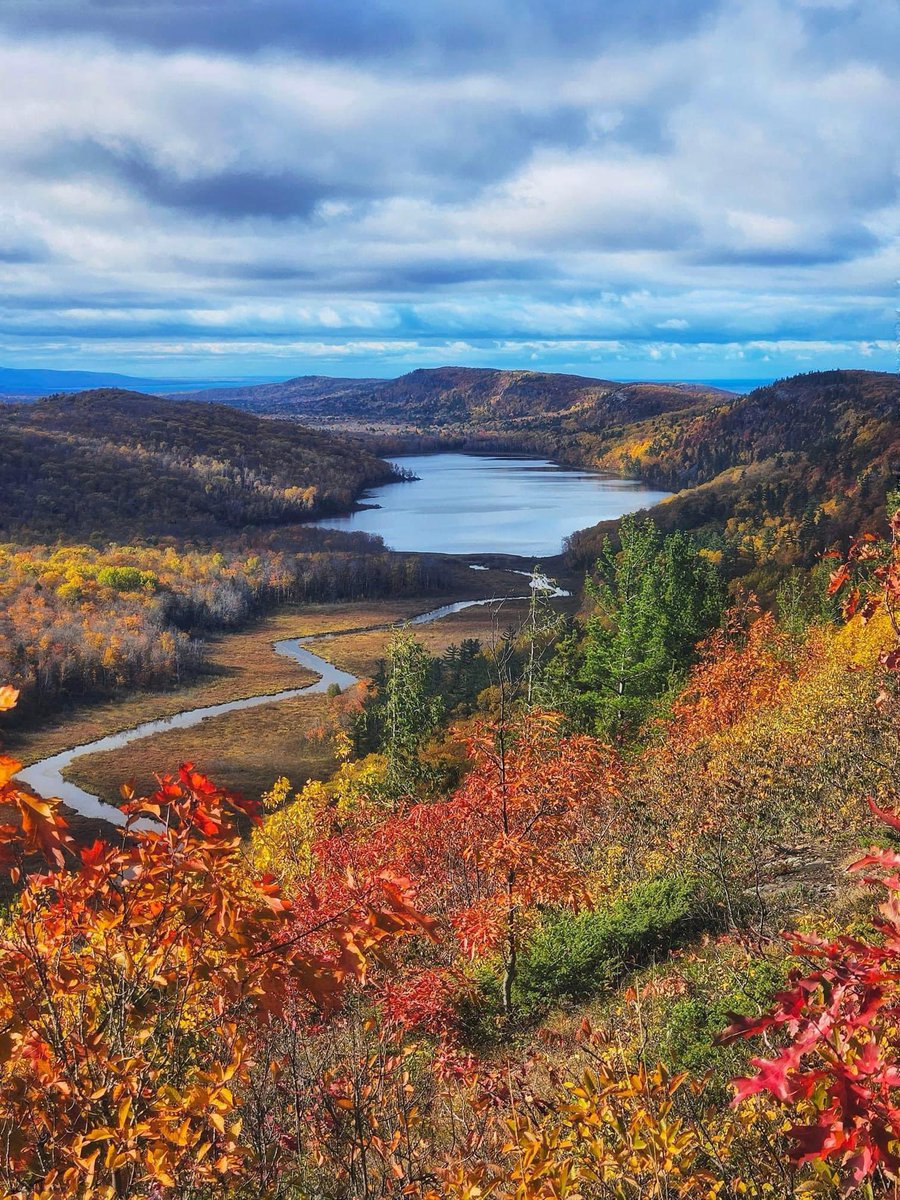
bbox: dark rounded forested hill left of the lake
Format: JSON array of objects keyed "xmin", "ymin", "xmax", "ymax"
[{"xmin": 0, "ymin": 389, "xmax": 392, "ymax": 540}]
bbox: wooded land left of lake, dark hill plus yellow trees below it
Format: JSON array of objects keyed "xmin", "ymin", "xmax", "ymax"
[{"xmin": 0, "ymin": 390, "xmax": 458, "ymax": 720}]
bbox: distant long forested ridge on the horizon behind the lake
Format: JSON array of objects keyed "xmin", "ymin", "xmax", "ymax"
[{"xmin": 170, "ymin": 367, "xmax": 730, "ymax": 432}]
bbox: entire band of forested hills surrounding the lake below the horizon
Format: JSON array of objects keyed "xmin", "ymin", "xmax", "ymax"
[{"xmin": 0, "ymin": 367, "xmax": 900, "ymax": 592}]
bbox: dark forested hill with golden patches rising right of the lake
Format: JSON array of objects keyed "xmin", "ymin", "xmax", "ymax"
[{"xmin": 571, "ymin": 371, "xmax": 900, "ymax": 586}]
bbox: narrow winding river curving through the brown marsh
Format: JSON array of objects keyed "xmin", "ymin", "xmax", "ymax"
[{"xmin": 16, "ymin": 585, "xmax": 568, "ymax": 826}]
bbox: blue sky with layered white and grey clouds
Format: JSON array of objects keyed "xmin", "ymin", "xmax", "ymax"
[{"xmin": 0, "ymin": 0, "xmax": 900, "ymax": 379}]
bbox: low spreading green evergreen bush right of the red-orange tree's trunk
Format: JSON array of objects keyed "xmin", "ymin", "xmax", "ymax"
[{"xmin": 516, "ymin": 877, "xmax": 709, "ymax": 1009}]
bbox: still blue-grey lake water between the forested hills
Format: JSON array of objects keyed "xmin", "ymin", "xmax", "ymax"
[{"xmin": 314, "ymin": 454, "xmax": 668, "ymax": 558}]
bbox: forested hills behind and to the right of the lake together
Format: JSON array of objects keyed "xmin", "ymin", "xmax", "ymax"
[{"xmin": 180, "ymin": 367, "xmax": 900, "ymax": 592}]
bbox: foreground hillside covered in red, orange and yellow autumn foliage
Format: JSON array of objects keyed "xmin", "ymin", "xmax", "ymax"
[{"xmin": 0, "ymin": 492, "xmax": 900, "ymax": 1200}]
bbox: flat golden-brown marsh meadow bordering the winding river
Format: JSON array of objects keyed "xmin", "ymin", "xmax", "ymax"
[{"xmin": 14, "ymin": 560, "xmax": 570, "ymax": 820}]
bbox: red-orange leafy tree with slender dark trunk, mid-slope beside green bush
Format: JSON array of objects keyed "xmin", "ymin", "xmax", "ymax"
[{"xmin": 316, "ymin": 712, "xmax": 619, "ymax": 1012}]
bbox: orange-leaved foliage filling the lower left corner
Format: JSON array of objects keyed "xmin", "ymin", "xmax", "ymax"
[{"xmin": 0, "ymin": 689, "xmax": 433, "ymax": 1200}]
